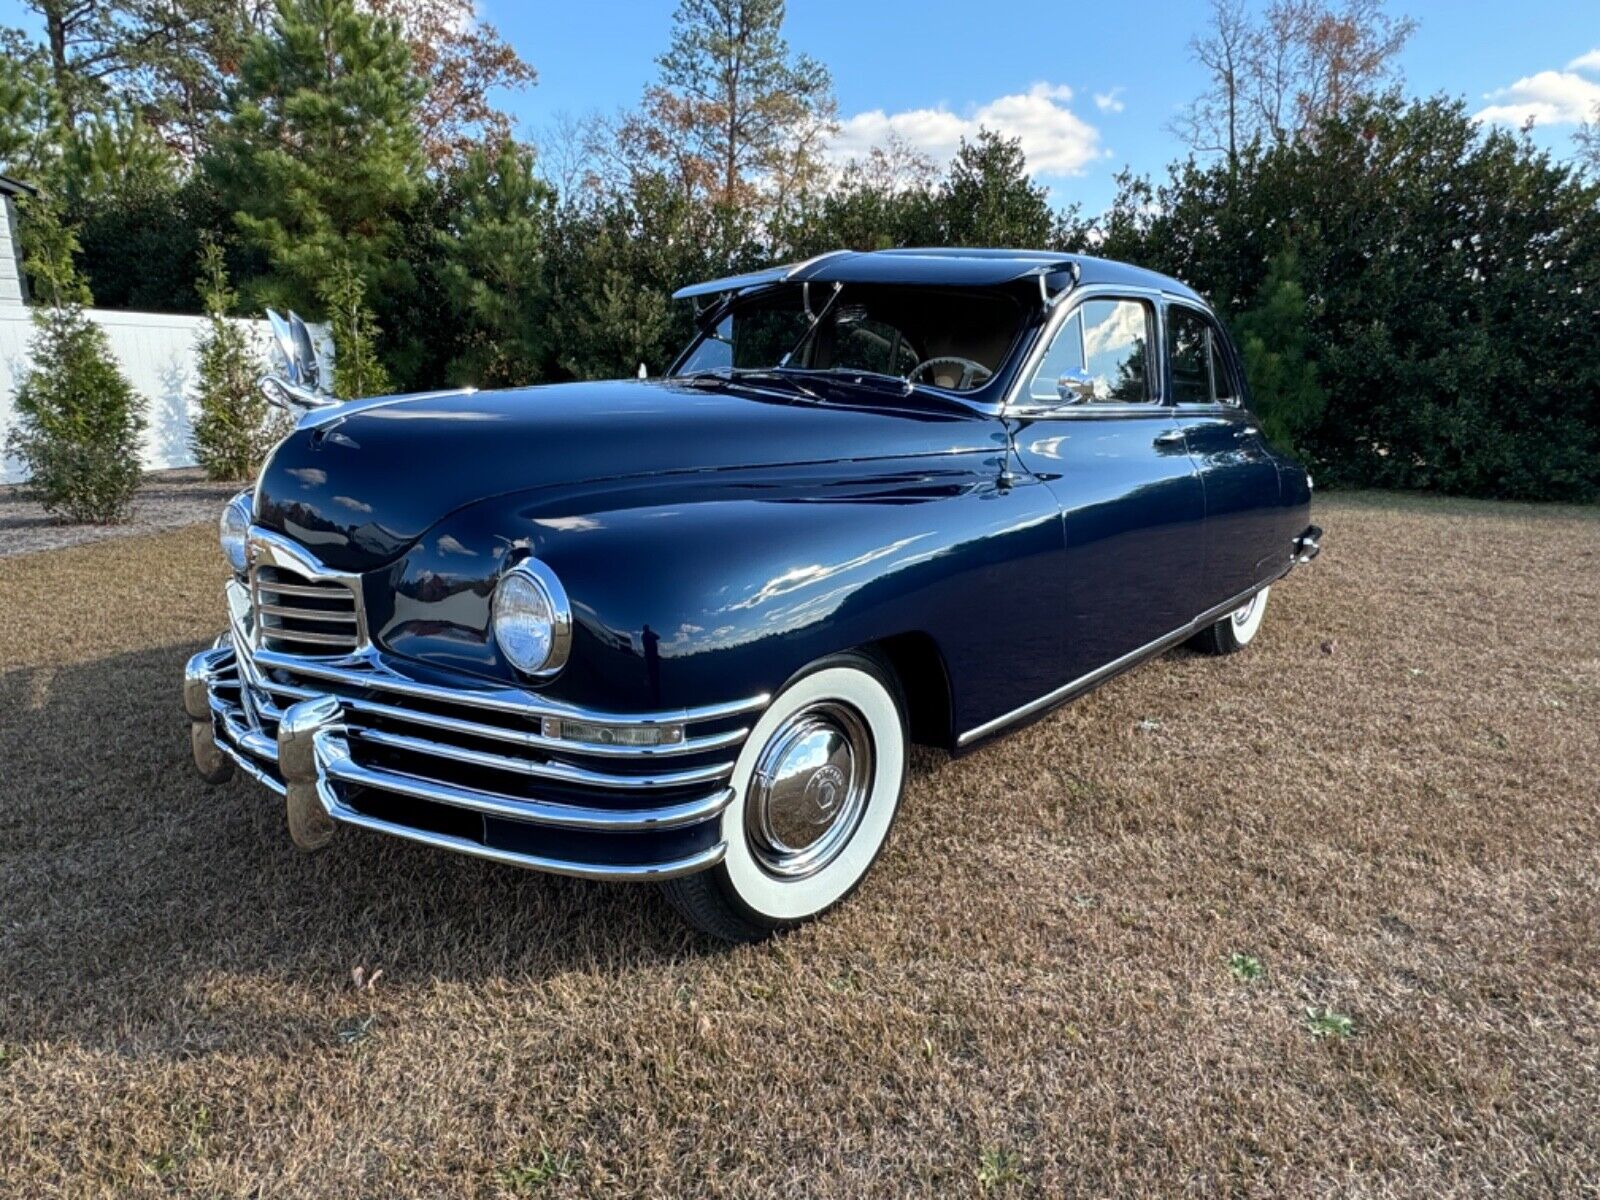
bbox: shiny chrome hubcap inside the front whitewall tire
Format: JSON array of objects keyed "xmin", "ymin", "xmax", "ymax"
[{"xmin": 744, "ymin": 701, "xmax": 872, "ymax": 878}]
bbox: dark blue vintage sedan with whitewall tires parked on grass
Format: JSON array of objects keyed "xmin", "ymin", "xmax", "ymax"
[{"xmin": 184, "ymin": 250, "xmax": 1320, "ymax": 939}]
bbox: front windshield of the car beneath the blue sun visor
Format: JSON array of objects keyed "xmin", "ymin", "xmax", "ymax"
[{"xmin": 677, "ymin": 285, "xmax": 1024, "ymax": 392}]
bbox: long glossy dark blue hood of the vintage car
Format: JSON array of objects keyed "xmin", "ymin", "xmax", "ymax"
[{"xmin": 254, "ymin": 379, "xmax": 1005, "ymax": 571}]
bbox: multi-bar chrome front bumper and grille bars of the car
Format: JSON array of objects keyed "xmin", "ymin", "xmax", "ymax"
[{"xmin": 184, "ymin": 584, "xmax": 768, "ymax": 880}]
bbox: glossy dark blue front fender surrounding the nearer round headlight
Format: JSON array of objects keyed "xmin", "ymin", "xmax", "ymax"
[{"xmin": 373, "ymin": 454, "xmax": 1061, "ymax": 739}]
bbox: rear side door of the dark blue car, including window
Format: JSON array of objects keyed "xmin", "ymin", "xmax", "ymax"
[{"xmin": 1166, "ymin": 302, "xmax": 1285, "ymax": 611}]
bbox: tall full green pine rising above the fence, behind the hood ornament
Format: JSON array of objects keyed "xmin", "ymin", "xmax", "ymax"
[{"xmin": 208, "ymin": 0, "xmax": 424, "ymax": 310}]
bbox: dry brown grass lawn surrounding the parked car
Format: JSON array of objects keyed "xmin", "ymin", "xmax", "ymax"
[{"xmin": 0, "ymin": 498, "xmax": 1600, "ymax": 1197}]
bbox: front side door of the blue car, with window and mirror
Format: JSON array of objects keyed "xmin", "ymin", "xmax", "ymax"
[{"xmin": 1008, "ymin": 290, "xmax": 1205, "ymax": 685}]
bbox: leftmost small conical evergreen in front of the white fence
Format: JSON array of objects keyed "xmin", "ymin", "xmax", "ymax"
[{"xmin": 6, "ymin": 200, "xmax": 144, "ymax": 525}]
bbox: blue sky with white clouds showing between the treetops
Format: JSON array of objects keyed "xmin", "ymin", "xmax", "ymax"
[{"xmin": 0, "ymin": 0, "xmax": 1600, "ymax": 211}]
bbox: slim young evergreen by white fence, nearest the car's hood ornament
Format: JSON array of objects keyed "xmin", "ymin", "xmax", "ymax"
[{"xmin": 190, "ymin": 242, "xmax": 285, "ymax": 480}]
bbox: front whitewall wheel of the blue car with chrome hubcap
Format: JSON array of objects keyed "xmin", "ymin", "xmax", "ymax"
[{"xmin": 662, "ymin": 653, "xmax": 907, "ymax": 942}]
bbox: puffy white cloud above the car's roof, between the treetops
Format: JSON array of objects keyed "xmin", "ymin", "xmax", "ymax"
[{"xmin": 830, "ymin": 83, "xmax": 1101, "ymax": 174}]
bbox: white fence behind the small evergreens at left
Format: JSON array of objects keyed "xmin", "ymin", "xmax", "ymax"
[{"xmin": 0, "ymin": 304, "xmax": 326, "ymax": 483}]
